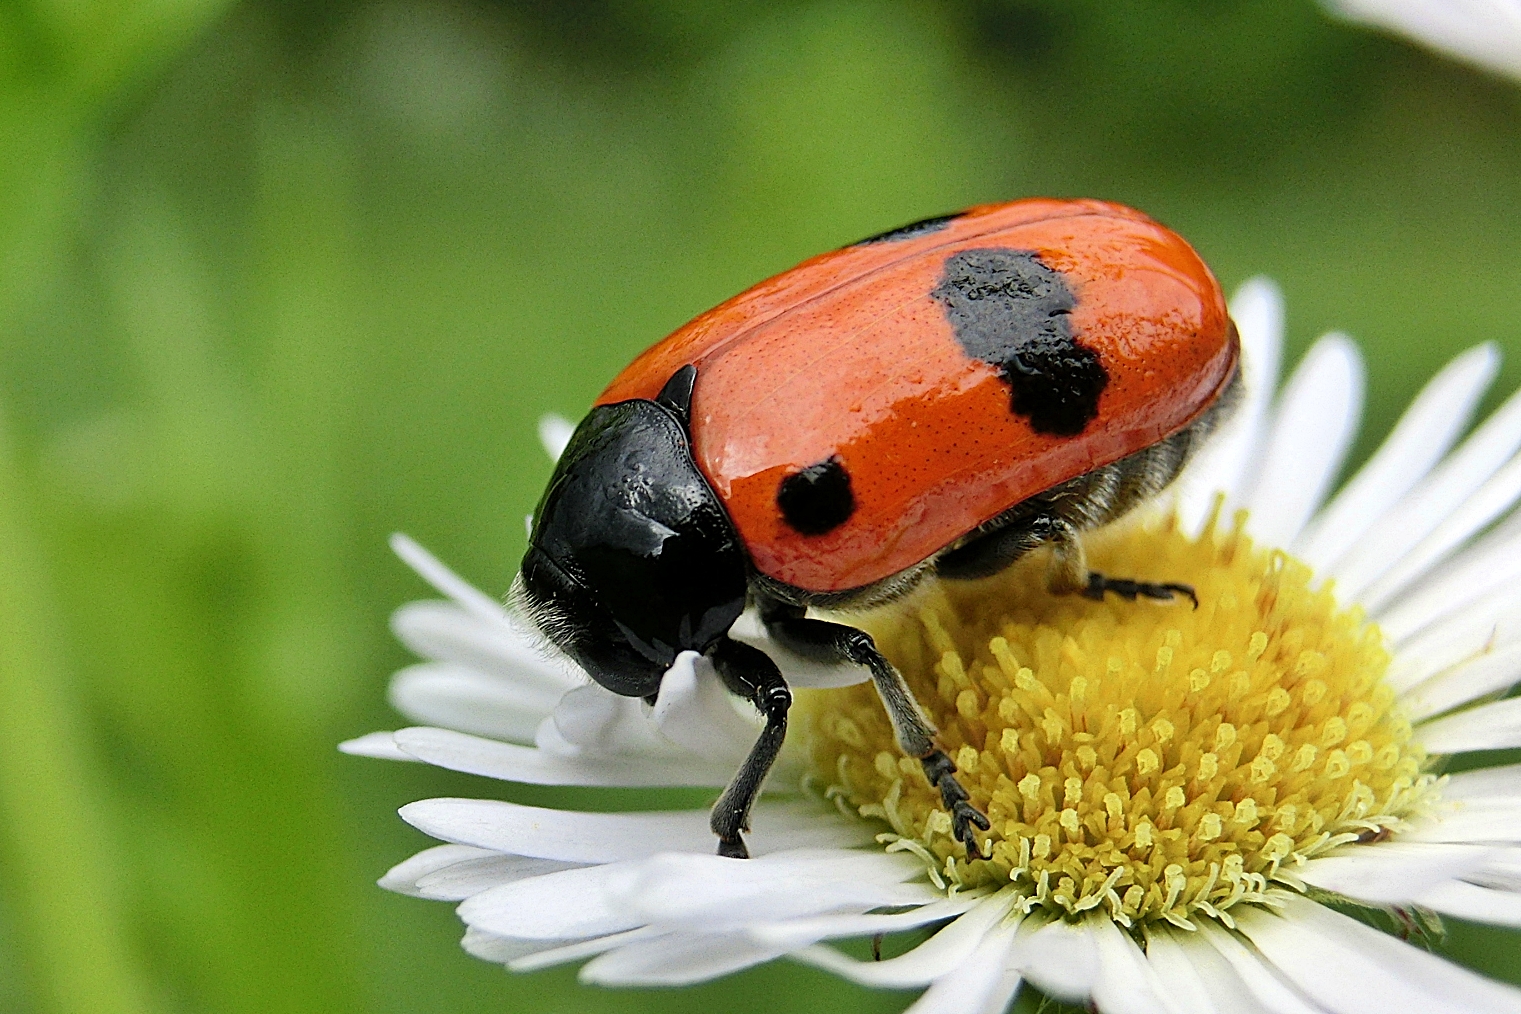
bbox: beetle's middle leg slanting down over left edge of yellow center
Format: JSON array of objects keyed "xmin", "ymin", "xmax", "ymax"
[{"xmin": 761, "ymin": 604, "xmax": 990, "ymax": 859}]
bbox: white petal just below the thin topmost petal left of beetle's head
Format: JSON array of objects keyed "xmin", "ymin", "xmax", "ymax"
[{"xmin": 391, "ymin": 600, "xmax": 586, "ymax": 695}]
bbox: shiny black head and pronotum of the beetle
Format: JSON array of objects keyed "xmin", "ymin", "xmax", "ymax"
[{"xmin": 520, "ymin": 374, "xmax": 747, "ymax": 696}]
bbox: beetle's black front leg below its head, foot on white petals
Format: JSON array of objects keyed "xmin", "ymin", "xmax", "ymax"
[{"xmin": 709, "ymin": 637, "xmax": 792, "ymax": 859}]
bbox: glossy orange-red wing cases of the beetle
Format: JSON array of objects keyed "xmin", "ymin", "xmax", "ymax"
[{"xmin": 598, "ymin": 201, "xmax": 1237, "ymax": 591}]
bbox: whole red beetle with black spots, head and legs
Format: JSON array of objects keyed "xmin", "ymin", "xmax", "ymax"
[{"xmin": 514, "ymin": 199, "xmax": 1240, "ymax": 857}]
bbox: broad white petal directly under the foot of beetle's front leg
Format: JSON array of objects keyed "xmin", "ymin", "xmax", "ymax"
[{"xmin": 607, "ymin": 850, "xmax": 941, "ymax": 932}]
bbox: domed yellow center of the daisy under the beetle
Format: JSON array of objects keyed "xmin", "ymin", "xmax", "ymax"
[{"xmin": 797, "ymin": 520, "xmax": 1433, "ymax": 927}]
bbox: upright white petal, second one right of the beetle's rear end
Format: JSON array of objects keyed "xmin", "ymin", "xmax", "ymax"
[{"xmin": 1246, "ymin": 333, "xmax": 1363, "ymax": 546}]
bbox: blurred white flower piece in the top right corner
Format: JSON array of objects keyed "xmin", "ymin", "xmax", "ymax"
[{"xmin": 1323, "ymin": 0, "xmax": 1521, "ymax": 78}]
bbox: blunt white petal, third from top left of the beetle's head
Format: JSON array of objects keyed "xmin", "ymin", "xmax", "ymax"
[{"xmin": 388, "ymin": 661, "xmax": 560, "ymax": 743}]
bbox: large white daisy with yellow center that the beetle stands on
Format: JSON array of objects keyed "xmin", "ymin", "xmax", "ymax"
[{"xmin": 344, "ymin": 273, "xmax": 1521, "ymax": 1014}]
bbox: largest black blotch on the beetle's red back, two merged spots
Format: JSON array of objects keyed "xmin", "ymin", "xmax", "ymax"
[{"xmin": 929, "ymin": 249, "xmax": 1109, "ymax": 436}]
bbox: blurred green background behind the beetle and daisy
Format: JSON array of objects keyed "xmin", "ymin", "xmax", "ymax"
[{"xmin": 0, "ymin": 0, "xmax": 1521, "ymax": 1014}]
